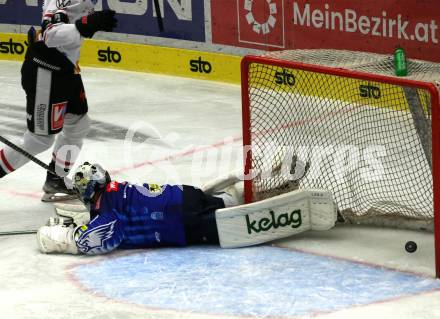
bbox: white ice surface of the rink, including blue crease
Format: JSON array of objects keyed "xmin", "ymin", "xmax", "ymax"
[{"xmin": 0, "ymin": 62, "xmax": 440, "ymax": 319}]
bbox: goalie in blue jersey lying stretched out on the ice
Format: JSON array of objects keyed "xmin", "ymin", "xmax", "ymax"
[{"xmin": 37, "ymin": 162, "xmax": 336, "ymax": 255}]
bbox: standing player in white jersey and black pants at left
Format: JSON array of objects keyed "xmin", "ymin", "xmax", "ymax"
[{"xmin": 0, "ymin": 0, "xmax": 117, "ymax": 201}]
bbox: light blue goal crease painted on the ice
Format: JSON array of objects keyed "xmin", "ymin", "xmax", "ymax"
[{"xmin": 71, "ymin": 246, "xmax": 440, "ymax": 318}]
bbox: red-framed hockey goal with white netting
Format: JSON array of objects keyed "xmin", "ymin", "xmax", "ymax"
[{"xmin": 241, "ymin": 50, "xmax": 440, "ymax": 278}]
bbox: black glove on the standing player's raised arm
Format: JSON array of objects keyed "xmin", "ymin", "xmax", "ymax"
[{"xmin": 75, "ymin": 10, "xmax": 118, "ymax": 38}]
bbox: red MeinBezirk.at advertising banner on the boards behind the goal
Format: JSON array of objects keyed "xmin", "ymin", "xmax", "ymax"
[{"xmin": 211, "ymin": 0, "xmax": 440, "ymax": 62}]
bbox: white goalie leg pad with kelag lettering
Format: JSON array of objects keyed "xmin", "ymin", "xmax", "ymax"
[{"xmin": 216, "ymin": 190, "xmax": 336, "ymax": 248}]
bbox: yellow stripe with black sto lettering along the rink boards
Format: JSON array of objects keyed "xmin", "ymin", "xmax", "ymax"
[{"xmin": 0, "ymin": 33, "xmax": 241, "ymax": 84}]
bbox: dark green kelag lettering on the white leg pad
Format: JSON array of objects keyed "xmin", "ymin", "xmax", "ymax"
[{"xmin": 245, "ymin": 209, "xmax": 302, "ymax": 235}]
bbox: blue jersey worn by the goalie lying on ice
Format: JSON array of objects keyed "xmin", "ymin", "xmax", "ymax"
[{"xmin": 76, "ymin": 181, "xmax": 186, "ymax": 254}]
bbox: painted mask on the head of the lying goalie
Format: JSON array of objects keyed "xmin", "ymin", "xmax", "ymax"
[{"xmin": 73, "ymin": 162, "xmax": 111, "ymax": 206}]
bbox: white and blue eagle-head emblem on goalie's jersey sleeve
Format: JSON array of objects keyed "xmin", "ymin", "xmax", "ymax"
[{"xmin": 76, "ymin": 220, "xmax": 116, "ymax": 253}]
